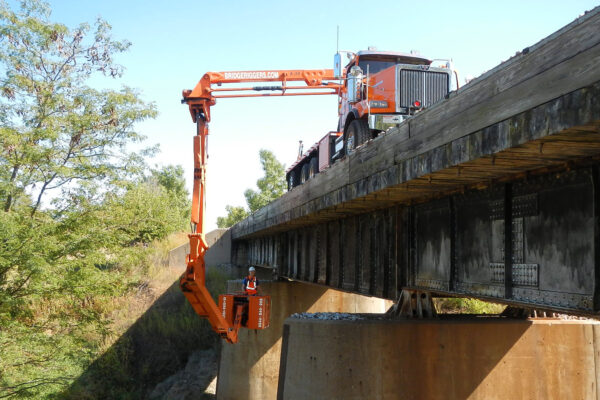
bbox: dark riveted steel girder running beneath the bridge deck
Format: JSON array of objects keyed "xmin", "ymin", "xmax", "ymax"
[{"xmin": 233, "ymin": 163, "xmax": 600, "ymax": 314}]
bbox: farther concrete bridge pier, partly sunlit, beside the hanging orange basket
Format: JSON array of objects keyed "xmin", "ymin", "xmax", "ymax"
[{"xmin": 217, "ymin": 281, "xmax": 391, "ymax": 400}]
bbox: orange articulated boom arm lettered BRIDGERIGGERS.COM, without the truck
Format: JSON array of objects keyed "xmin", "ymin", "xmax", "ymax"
[{"xmin": 179, "ymin": 69, "xmax": 341, "ymax": 343}]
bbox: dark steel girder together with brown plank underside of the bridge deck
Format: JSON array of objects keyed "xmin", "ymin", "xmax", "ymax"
[{"xmin": 233, "ymin": 81, "xmax": 600, "ymax": 314}]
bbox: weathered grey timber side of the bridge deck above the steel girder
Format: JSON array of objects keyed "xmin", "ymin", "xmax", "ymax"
[{"xmin": 232, "ymin": 12, "xmax": 600, "ymax": 238}]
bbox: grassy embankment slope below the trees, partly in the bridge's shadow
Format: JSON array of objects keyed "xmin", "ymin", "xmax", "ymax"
[{"xmin": 0, "ymin": 234, "xmax": 228, "ymax": 400}]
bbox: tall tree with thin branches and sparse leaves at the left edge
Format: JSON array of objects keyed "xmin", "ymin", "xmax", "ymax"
[{"xmin": 0, "ymin": 0, "xmax": 156, "ymax": 312}]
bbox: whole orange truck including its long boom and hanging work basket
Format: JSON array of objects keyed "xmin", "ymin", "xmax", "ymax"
[{"xmin": 180, "ymin": 49, "xmax": 458, "ymax": 343}]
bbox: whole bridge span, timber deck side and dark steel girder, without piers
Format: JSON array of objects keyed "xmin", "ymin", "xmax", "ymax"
[{"xmin": 231, "ymin": 8, "xmax": 600, "ymax": 315}]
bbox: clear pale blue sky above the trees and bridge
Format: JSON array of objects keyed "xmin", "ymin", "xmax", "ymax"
[{"xmin": 34, "ymin": 0, "xmax": 599, "ymax": 230}]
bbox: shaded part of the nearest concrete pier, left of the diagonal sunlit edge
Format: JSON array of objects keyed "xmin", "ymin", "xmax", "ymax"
[{"xmin": 277, "ymin": 315, "xmax": 543, "ymax": 399}]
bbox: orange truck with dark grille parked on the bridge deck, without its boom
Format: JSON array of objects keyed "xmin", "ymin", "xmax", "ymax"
[{"xmin": 286, "ymin": 48, "xmax": 458, "ymax": 190}]
